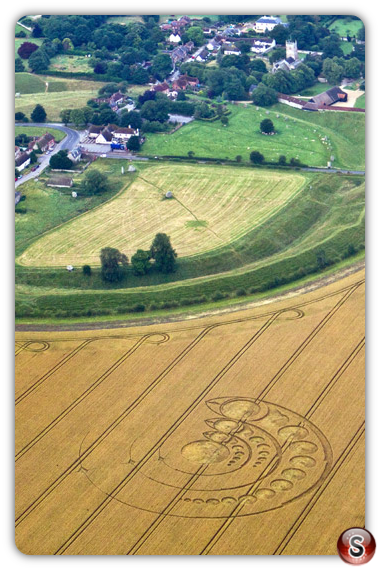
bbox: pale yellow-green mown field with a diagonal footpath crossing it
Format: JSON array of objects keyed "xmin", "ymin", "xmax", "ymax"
[{"xmin": 18, "ymin": 164, "xmax": 305, "ymax": 267}]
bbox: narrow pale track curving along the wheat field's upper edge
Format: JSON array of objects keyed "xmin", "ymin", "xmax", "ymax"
[{"xmin": 15, "ymin": 260, "xmax": 365, "ymax": 332}]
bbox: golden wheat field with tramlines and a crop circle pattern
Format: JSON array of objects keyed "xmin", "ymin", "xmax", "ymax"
[{"xmin": 16, "ymin": 271, "xmax": 365, "ymax": 555}]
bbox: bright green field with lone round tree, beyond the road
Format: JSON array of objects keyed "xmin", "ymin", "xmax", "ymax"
[{"xmin": 141, "ymin": 104, "xmax": 365, "ymax": 170}]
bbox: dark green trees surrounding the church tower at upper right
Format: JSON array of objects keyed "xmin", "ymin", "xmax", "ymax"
[{"xmin": 181, "ymin": 15, "xmax": 365, "ymax": 106}]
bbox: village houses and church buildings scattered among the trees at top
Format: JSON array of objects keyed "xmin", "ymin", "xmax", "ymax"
[{"xmin": 15, "ymin": 16, "xmax": 366, "ymax": 186}]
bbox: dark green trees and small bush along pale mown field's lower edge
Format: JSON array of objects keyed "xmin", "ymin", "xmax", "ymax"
[{"xmin": 96, "ymin": 233, "xmax": 177, "ymax": 283}]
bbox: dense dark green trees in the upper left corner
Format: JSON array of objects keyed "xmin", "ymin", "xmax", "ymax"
[{"xmin": 16, "ymin": 15, "xmax": 178, "ymax": 81}]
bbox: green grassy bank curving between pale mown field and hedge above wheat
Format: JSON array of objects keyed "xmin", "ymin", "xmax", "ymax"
[{"xmin": 16, "ymin": 160, "xmax": 364, "ymax": 314}]
